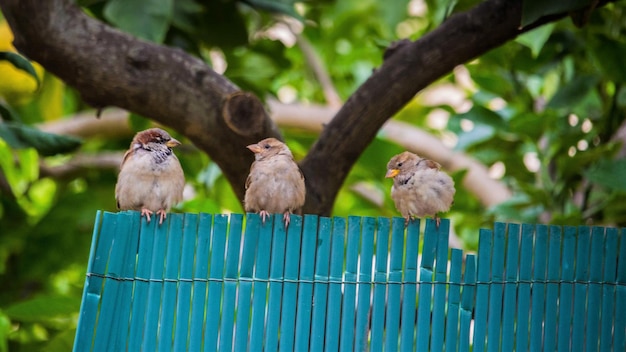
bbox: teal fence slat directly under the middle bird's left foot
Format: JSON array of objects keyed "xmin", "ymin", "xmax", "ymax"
[{"xmin": 250, "ymin": 216, "xmax": 276, "ymax": 349}]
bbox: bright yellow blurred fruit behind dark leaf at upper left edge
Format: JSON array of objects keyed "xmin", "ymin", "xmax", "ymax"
[{"xmin": 0, "ymin": 21, "xmax": 44, "ymax": 105}]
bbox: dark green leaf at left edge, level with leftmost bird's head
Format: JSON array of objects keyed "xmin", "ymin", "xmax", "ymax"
[{"xmin": 0, "ymin": 122, "xmax": 82, "ymax": 156}]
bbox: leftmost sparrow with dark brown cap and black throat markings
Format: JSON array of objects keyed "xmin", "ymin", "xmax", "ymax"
[{"xmin": 115, "ymin": 128, "xmax": 185, "ymax": 224}]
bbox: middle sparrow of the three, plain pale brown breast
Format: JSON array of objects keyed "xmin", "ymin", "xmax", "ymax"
[{"xmin": 244, "ymin": 138, "xmax": 305, "ymax": 226}]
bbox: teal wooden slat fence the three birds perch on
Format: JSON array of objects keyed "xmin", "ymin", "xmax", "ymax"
[{"xmin": 74, "ymin": 212, "xmax": 626, "ymax": 351}]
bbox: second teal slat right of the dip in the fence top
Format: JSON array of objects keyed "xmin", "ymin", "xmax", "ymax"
[{"xmin": 487, "ymin": 222, "xmax": 506, "ymax": 351}]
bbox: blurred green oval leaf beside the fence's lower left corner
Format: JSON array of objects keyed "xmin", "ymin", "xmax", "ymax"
[{"xmin": 4, "ymin": 296, "xmax": 80, "ymax": 322}]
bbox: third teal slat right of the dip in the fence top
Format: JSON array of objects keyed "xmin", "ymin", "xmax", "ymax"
[{"xmin": 501, "ymin": 224, "xmax": 520, "ymax": 351}]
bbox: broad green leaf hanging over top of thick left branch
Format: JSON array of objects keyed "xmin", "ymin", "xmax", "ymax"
[{"xmin": 104, "ymin": 0, "xmax": 174, "ymax": 43}]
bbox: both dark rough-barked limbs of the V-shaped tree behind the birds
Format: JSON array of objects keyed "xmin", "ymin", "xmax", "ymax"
[{"xmin": 0, "ymin": 0, "xmax": 584, "ymax": 215}]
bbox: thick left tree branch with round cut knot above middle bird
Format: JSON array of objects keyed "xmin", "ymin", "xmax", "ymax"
[{"xmin": 0, "ymin": 0, "xmax": 279, "ymax": 204}]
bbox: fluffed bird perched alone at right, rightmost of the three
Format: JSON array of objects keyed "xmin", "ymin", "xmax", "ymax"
[{"xmin": 385, "ymin": 152, "xmax": 456, "ymax": 227}]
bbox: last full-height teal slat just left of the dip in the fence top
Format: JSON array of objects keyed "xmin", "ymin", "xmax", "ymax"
[{"xmin": 426, "ymin": 219, "xmax": 450, "ymax": 351}]
